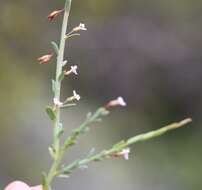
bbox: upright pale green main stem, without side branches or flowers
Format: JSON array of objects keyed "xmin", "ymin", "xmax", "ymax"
[{"xmin": 46, "ymin": 0, "xmax": 72, "ymax": 187}]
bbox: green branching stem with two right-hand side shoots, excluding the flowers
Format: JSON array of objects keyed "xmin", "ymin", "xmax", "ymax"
[{"xmin": 42, "ymin": 0, "xmax": 191, "ymax": 190}]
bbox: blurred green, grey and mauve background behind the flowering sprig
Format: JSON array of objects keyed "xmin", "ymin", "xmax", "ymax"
[{"xmin": 0, "ymin": 0, "xmax": 202, "ymax": 190}]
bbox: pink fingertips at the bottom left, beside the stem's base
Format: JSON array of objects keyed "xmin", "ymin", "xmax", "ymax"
[{"xmin": 4, "ymin": 181, "xmax": 42, "ymax": 190}]
